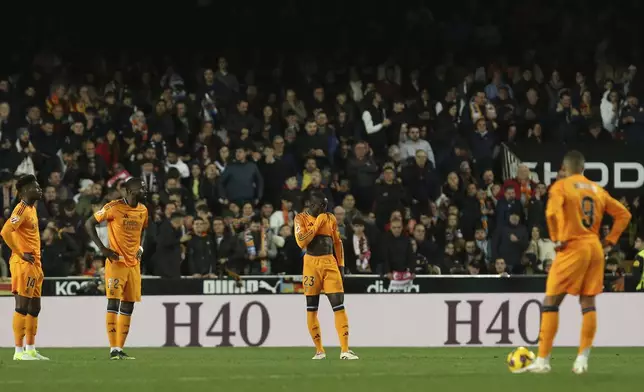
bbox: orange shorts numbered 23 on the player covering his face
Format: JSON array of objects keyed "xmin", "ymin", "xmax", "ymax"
[{"xmin": 302, "ymin": 255, "xmax": 344, "ymax": 295}]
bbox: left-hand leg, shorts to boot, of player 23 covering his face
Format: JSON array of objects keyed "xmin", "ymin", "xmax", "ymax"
[{"xmin": 302, "ymin": 255, "xmax": 326, "ymax": 359}]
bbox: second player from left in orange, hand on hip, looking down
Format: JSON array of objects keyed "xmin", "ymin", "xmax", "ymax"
[{"xmin": 85, "ymin": 178, "xmax": 148, "ymax": 360}]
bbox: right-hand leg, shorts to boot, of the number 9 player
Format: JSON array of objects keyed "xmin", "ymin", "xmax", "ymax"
[{"xmin": 572, "ymin": 242, "xmax": 604, "ymax": 374}]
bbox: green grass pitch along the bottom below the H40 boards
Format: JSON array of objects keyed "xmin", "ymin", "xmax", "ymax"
[{"xmin": 0, "ymin": 348, "xmax": 644, "ymax": 392}]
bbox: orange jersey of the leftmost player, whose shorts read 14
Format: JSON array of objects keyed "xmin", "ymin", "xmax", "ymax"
[{"xmin": 2, "ymin": 201, "xmax": 41, "ymax": 266}]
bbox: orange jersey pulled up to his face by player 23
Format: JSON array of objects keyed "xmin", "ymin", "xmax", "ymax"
[{"xmin": 294, "ymin": 212, "xmax": 344, "ymax": 266}]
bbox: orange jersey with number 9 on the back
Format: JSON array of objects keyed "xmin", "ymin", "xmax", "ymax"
[{"xmin": 546, "ymin": 174, "xmax": 631, "ymax": 244}]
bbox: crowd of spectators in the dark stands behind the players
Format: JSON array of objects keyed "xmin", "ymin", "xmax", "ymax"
[{"xmin": 0, "ymin": 2, "xmax": 644, "ymax": 277}]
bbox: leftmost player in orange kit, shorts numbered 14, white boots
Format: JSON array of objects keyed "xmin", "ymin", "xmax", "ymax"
[{"xmin": 0, "ymin": 175, "xmax": 49, "ymax": 361}]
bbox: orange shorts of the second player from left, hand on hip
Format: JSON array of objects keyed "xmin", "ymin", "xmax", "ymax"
[{"xmin": 105, "ymin": 260, "xmax": 141, "ymax": 302}]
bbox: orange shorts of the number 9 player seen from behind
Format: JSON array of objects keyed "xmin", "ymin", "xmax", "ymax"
[{"xmin": 546, "ymin": 239, "xmax": 605, "ymax": 296}]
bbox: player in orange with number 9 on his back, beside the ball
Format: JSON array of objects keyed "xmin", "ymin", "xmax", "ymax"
[{"xmin": 525, "ymin": 151, "xmax": 631, "ymax": 374}]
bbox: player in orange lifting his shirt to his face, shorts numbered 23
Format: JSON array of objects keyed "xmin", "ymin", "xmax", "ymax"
[{"xmin": 295, "ymin": 191, "xmax": 358, "ymax": 359}]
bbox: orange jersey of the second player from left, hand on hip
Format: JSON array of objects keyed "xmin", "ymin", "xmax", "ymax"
[{"xmin": 94, "ymin": 199, "xmax": 148, "ymax": 267}]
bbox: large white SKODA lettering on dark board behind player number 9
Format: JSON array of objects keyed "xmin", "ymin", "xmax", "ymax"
[{"xmin": 523, "ymin": 162, "xmax": 644, "ymax": 189}]
